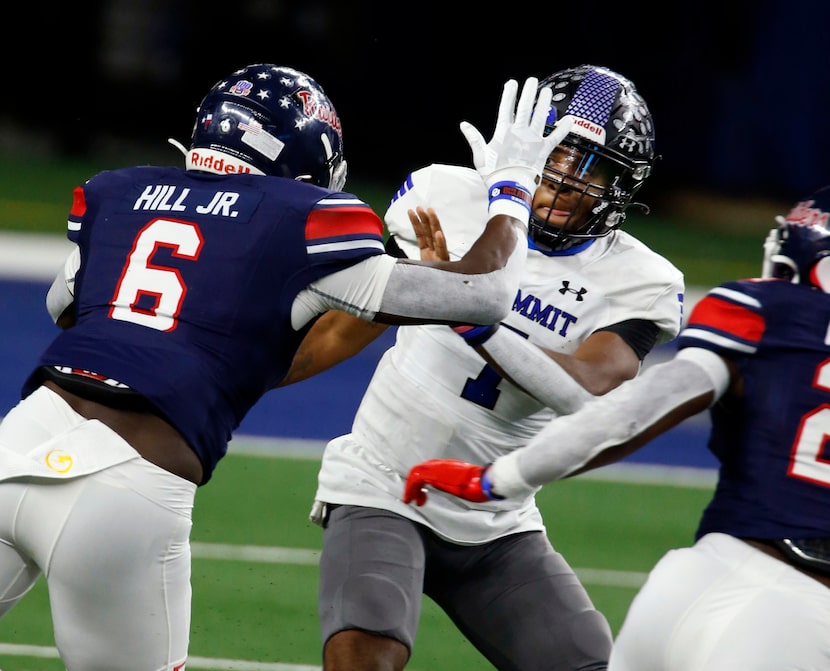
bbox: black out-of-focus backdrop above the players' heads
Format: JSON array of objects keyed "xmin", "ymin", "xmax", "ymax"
[{"xmin": 0, "ymin": 0, "xmax": 830, "ymax": 215}]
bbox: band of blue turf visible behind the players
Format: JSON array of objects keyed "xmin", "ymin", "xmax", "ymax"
[{"xmin": 0, "ymin": 279, "xmax": 716, "ymax": 468}]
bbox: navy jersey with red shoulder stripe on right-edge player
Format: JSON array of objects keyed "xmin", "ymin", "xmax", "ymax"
[{"xmin": 678, "ymin": 280, "xmax": 830, "ymax": 539}]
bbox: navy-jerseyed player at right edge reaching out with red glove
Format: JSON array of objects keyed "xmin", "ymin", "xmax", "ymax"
[{"xmin": 404, "ymin": 187, "xmax": 830, "ymax": 671}]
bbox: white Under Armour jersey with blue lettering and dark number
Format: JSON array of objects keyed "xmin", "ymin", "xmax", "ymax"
[{"xmin": 316, "ymin": 165, "xmax": 683, "ymax": 544}]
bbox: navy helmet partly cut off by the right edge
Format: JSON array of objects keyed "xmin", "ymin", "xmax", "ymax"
[{"xmin": 761, "ymin": 186, "xmax": 830, "ymax": 293}]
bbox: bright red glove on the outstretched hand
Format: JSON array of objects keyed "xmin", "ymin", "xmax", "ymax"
[{"xmin": 403, "ymin": 459, "xmax": 501, "ymax": 506}]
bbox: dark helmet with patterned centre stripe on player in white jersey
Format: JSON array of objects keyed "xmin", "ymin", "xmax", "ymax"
[{"xmin": 529, "ymin": 65, "xmax": 656, "ymax": 250}]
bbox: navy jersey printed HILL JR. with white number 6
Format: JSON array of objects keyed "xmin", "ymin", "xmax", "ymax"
[{"xmin": 23, "ymin": 167, "xmax": 383, "ymax": 483}]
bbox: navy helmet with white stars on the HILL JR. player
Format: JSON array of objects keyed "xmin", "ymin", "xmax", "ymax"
[{"xmin": 179, "ymin": 63, "xmax": 346, "ymax": 191}]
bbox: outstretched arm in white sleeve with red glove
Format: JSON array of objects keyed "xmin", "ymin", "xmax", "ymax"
[{"xmin": 404, "ymin": 347, "xmax": 740, "ymax": 505}]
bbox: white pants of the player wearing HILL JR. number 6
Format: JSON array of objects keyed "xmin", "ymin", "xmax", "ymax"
[{"xmin": 0, "ymin": 387, "xmax": 196, "ymax": 671}]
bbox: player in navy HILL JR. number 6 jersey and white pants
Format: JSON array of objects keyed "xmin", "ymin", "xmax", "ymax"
[{"xmin": 0, "ymin": 64, "xmax": 567, "ymax": 671}]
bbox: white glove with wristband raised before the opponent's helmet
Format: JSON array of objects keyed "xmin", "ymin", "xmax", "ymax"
[{"xmin": 461, "ymin": 77, "xmax": 573, "ymax": 222}]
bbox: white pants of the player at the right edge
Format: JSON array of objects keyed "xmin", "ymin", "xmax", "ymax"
[{"xmin": 608, "ymin": 534, "xmax": 830, "ymax": 671}]
